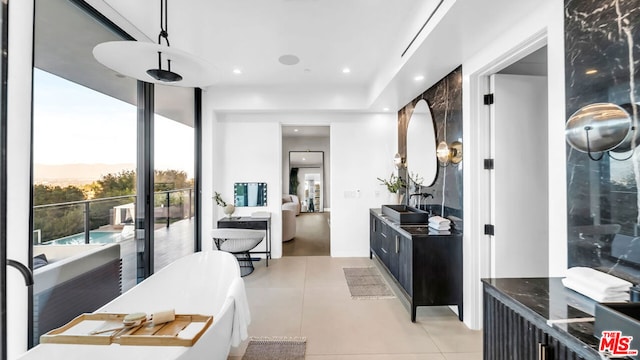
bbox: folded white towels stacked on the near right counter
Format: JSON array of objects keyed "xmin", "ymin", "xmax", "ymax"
[{"xmin": 562, "ymin": 267, "xmax": 633, "ymax": 302}]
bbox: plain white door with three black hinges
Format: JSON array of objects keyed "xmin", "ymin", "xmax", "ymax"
[{"xmin": 488, "ymin": 74, "xmax": 549, "ymax": 277}]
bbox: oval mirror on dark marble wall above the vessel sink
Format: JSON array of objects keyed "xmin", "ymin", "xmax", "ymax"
[{"xmin": 406, "ymin": 100, "xmax": 438, "ymax": 186}]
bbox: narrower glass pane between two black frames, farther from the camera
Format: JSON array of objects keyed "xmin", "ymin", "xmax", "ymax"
[{"xmin": 153, "ymin": 85, "xmax": 196, "ymax": 271}]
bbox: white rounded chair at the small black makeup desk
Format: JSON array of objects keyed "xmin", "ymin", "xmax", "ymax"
[{"xmin": 211, "ymin": 228, "xmax": 265, "ymax": 276}]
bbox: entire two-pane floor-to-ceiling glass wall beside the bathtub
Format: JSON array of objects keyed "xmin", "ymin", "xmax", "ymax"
[{"xmin": 25, "ymin": 0, "xmax": 195, "ymax": 344}]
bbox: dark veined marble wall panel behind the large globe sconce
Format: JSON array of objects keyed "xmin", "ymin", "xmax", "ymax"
[{"xmin": 564, "ymin": 0, "xmax": 640, "ymax": 283}]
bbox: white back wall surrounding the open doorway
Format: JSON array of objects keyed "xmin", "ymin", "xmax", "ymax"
[{"xmin": 203, "ymin": 111, "xmax": 397, "ymax": 258}]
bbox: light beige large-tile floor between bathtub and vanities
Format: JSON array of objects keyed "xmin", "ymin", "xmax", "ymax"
[{"xmin": 229, "ymin": 256, "xmax": 482, "ymax": 360}]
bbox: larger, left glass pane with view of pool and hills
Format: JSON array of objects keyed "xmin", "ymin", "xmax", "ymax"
[{"xmin": 30, "ymin": 0, "xmax": 138, "ymax": 345}]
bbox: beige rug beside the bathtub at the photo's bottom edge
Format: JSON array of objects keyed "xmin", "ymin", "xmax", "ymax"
[{"xmin": 242, "ymin": 337, "xmax": 307, "ymax": 360}]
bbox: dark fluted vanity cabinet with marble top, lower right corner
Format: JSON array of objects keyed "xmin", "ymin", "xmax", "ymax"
[{"xmin": 482, "ymin": 278, "xmax": 601, "ymax": 360}]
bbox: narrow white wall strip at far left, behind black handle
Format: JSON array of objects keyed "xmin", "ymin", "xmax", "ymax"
[{"xmin": 7, "ymin": 0, "xmax": 33, "ymax": 359}]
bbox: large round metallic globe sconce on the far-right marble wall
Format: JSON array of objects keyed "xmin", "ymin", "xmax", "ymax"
[{"xmin": 565, "ymin": 103, "xmax": 640, "ymax": 161}]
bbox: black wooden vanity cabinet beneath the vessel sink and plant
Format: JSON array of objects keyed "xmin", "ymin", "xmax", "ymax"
[{"xmin": 369, "ymin": 210, "xmax": 463, "ymax": 322}]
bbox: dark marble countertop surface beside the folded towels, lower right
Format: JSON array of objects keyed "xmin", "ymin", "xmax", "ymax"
[{"xmin": 482, "ymin": 278, "xmax": 599, "ymax": 358}]
